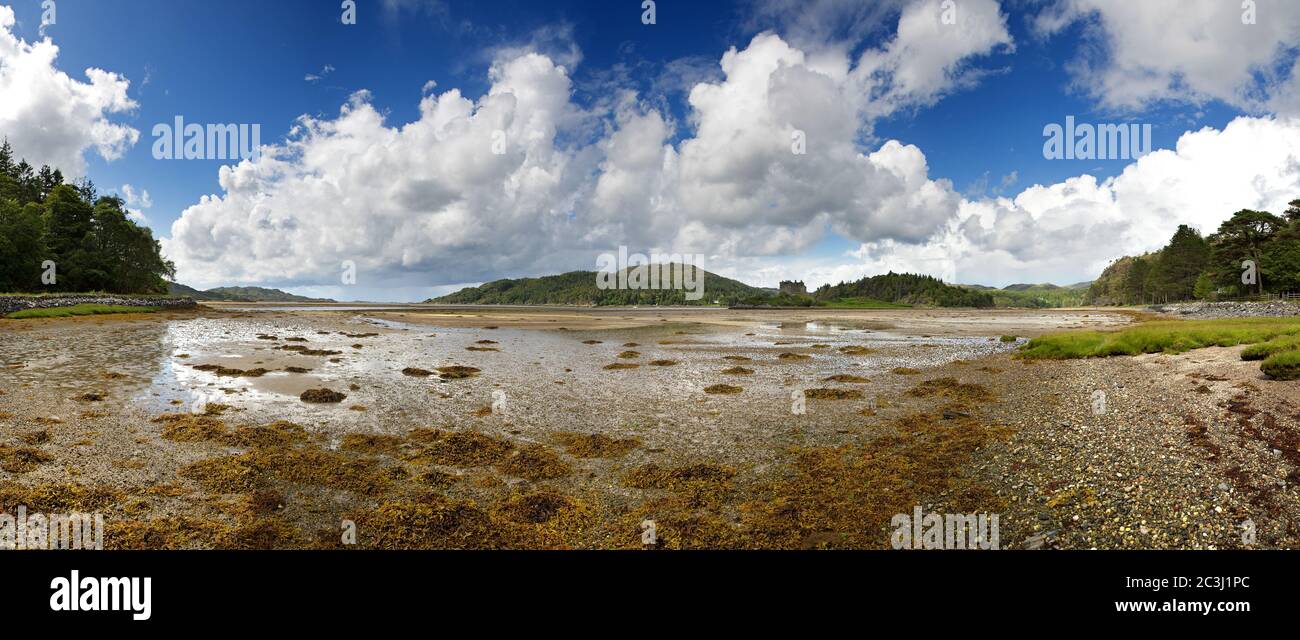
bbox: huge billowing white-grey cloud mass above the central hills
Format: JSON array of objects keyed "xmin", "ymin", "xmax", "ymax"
[{"xmin": 165, "ymin": 14, "xmax": 1006, "ymax": 286}]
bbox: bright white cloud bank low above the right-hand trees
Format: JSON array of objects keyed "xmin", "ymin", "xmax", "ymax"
[{"xmin": 954, "ymin": 116, "xmax": 1300, "ymax": 282}]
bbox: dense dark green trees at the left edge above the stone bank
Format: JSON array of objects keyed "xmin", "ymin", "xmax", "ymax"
[{"xmin": 0, "ymin": 140, "xmax": 176, "ymax": 294}]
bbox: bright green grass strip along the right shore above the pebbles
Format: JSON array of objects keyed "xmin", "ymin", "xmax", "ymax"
[{"xmin": 1018, "ymin": 317, "xmax": 1300, "ymax": 360}]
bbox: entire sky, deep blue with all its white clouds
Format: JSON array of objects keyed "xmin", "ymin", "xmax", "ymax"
[{"xmin": 0, "ymin": 0, "xmax": 1300, "ymax": 302}]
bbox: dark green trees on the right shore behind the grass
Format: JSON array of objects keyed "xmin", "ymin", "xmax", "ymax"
[{"xmin": 1088, "ymin": 199, "xmax": 1300, "ymax": 304}]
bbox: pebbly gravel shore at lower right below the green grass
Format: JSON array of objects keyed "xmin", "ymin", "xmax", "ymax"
[{"xmin": 974, "ymin": 347, "xmax": 1300, "ymax": 549}]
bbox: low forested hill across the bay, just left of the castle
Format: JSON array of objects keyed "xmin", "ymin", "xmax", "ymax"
[{"xmin": 425, "ymin": 269, "xmax": 771, "ymax": 306}]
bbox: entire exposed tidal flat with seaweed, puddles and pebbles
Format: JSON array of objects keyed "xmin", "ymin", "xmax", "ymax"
[{"xmin": 0, "ymin": 304, "xmax": 1300, "ymax": 549}]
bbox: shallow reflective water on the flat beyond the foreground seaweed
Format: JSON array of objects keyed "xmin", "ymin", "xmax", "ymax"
[{"xmin": 0, "ymin": 310, "xmax": 1014, "ymax": 458}]
